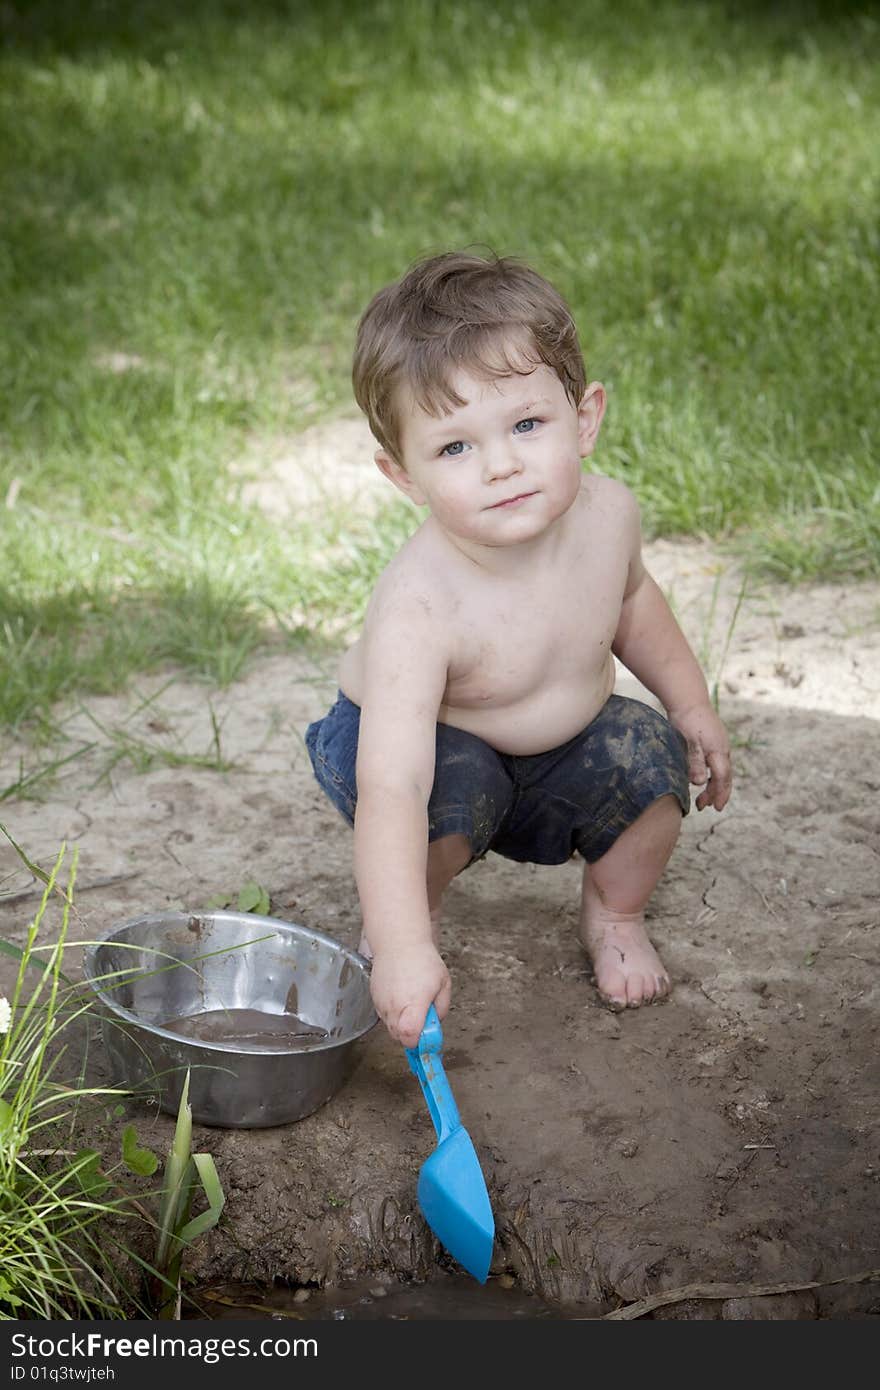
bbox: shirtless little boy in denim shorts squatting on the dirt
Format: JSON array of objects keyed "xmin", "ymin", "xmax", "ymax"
[{"xmin": 306, "ymin": 253, "xmax": 731, "ymax": 1047}]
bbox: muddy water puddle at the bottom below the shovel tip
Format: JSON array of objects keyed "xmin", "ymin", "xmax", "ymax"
[{"xmin": 184, "ymin": 1273, "xmax": 601, "ymax": 1322}]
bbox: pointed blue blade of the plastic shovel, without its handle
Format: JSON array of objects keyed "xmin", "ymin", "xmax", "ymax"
[{"xmin": 417, "ymin": 1129, "xmax": 495, "ymax": 1284}]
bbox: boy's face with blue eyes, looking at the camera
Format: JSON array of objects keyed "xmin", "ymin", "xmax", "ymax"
[{"xmin": 375, "ymin": 363, "xmax": 605, "ymax": 546}]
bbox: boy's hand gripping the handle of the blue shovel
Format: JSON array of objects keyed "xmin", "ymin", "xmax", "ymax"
[{"xmin": 370, "ymin": 941, "xmax": 452, "ymax": 1047}]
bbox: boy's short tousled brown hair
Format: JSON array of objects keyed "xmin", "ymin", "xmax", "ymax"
[{"xmin": 352, "ymin": 252, "xmax": 587, "ymax": 463}]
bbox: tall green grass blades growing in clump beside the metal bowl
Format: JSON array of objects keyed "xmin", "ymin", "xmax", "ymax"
[{"xmin": 0, "ymin": 824, "xmax": 227, "ymax": 1322}]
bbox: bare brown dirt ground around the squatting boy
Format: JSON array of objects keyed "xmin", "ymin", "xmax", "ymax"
[{"xmin": 0, "ymin": 421, "xmax": 880, "ymax": 1318}]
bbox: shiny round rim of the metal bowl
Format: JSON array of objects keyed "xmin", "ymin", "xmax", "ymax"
[{"xmin": 82, "ymin": 908, "xmax": 378, "ymax": 1058}]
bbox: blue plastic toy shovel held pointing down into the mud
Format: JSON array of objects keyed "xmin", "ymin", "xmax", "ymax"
[{"xmin": 406, "ymin": 1005, "xmax": 495, "ymax": 1284}]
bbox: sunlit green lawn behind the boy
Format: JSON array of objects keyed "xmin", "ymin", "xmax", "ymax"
[{"xmin": 0, "ymin": 0, "xmax": 880, "ymax": 733}]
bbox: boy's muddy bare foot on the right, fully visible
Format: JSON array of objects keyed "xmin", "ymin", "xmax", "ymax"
[{"xmin": 581, "ymin": 894, "xmax": 671, "ymax": 1011}]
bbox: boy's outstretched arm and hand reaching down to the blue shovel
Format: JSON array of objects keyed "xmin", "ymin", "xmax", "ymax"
[{"xmin": 355, "ymin": 583, "xmax": 450, "ymax": 1047}]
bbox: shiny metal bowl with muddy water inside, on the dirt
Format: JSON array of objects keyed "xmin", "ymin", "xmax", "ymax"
[{"xmin": 82, "ymin": 912, "xmax": 377, "ymax": 1129}]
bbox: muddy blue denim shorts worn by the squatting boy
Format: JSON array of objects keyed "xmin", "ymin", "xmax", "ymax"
[{"xmin": 306, "ymin": 691, "xmax": 691, "ymax": 865}]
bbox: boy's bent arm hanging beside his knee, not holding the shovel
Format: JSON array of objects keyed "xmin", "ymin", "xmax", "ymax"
[{"xmin": 612, "ymin": 499, "xmax": 733, "ymax": 810}]
